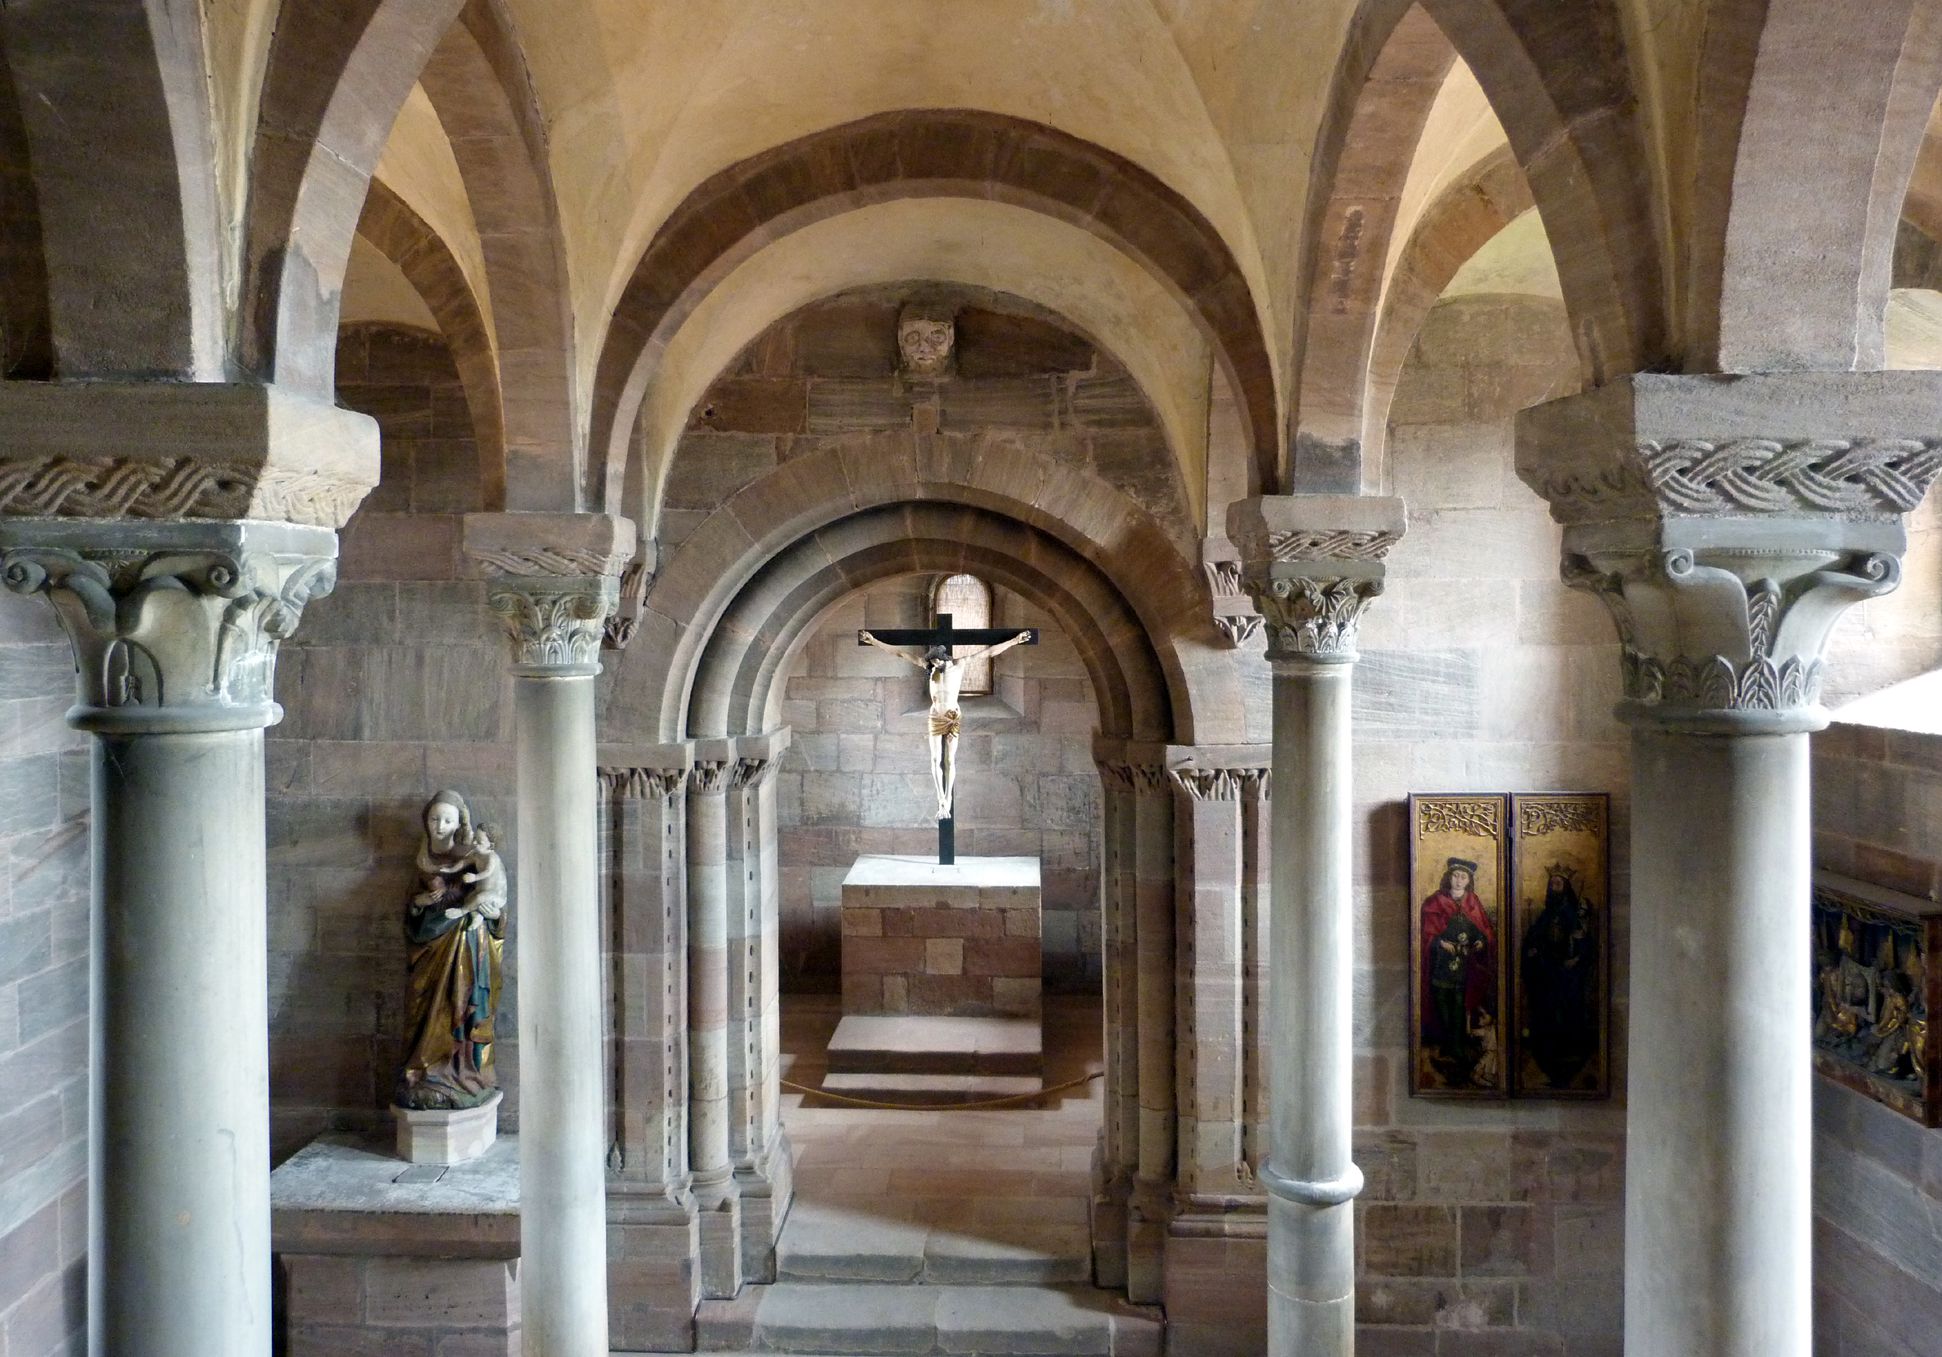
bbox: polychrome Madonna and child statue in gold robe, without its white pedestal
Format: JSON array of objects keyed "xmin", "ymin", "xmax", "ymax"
[{"xmin": 392, "ymin": 790, "xmax": 505, "ymax": 1110}]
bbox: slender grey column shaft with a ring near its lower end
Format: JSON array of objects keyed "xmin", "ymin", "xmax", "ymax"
[{"xmin": 1266, "ymin": 658, "xmax": 1359, "ymax": 1357}]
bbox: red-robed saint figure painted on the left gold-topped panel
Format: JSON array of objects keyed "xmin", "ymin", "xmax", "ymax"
[{"xmin": 1420, "ymin": 858, "xmax": 1497, "ymax": 1089}]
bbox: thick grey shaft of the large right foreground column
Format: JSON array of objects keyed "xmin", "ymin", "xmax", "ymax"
[{"xmin": 1625, "ymin": 728, "xmax": 1814, "ymax": 1357}]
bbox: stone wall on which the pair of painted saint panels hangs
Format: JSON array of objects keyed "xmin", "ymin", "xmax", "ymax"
[{"xmin": 1281, "ymin": 295, "xmax": 1629, "ymax": 1357}]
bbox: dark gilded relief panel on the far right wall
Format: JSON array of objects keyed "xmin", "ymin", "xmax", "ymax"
[{"xmin": 1812, "ymin": 872, "xmax": 1942, "ymax": 1126}]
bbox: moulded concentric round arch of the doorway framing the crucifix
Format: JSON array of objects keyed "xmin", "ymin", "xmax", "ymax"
[{"xmin": 687, "ymin": 503, "xmax": 1173, "ymax": 742}]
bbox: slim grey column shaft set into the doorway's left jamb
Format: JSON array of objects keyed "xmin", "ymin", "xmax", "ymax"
[{"xmin": 687, "ymin": 788, "xmax": 730, "ymax": 1198}]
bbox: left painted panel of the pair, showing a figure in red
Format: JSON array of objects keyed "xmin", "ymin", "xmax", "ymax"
[{"xmin": 1410, "ymin": 794, "xmax": 1511, "ymax": 1099}]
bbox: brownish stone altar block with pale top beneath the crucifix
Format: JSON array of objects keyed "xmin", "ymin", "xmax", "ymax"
[{"xmin": 843, "ymin": 854, "xmax": 1043, "ymax": 1019}]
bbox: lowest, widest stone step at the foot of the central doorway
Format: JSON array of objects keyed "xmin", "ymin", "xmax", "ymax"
[{"xmin": 697, "ymin": 1281, "xmax": 1161, "ymax": 1357}]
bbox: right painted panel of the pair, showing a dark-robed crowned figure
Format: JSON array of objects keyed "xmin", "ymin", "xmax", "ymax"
[{"xmin": 1511, "ymin": 792, "xmax": 1612, "ymax": 1099}]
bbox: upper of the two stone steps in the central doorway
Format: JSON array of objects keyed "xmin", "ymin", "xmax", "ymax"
[{"xmin": 775, "ymin": 1202, "xmax": 1091, "ymax": 1285}]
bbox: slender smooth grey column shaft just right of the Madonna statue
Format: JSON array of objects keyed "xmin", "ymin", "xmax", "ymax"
[{"xmin": 513, "ymin": 672, "xmax": 608, "ymax": 1357}]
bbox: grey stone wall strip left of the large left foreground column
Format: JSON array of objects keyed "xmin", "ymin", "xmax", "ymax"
[{"xmin": 0, "ymin": 594, "xmax": 87, "ymax": 1357}]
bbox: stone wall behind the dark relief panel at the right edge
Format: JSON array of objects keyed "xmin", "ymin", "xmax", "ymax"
[{"xmin": 1800, "ymin": 724, "xmax": 1942, "ymax": 1357}]
